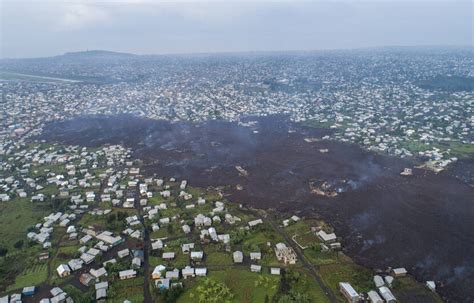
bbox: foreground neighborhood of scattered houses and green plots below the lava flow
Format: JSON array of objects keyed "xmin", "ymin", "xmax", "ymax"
[{"xmin": 0, "ymin": 142, "xmax": 444, "ymax": 303}]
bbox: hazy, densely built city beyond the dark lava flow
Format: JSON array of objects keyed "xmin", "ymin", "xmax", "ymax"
[{"xmin": 0, "ymin": 50, "xmax": 474, "ymax": 175}]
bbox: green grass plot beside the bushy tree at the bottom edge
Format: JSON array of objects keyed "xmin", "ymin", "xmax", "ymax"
[{"xmin": 178, "ymin": 269, "xmax": 280, "ymax": 303}]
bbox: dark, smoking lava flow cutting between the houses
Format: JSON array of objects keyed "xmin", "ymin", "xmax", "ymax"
[{"xmin": 42, "ymin": 116, "xmax": 474, "ymax": 302}]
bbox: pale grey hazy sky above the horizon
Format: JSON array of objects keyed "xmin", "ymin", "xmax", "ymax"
[{"xmin": 0, "ymin": 0, "xmax": 474, "ymax": 57}]
